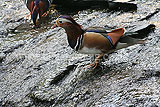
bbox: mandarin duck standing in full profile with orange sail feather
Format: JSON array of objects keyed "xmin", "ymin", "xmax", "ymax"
[{"xmin": 52, "ymin": 16, "xmax": 145, "ymax": 68}]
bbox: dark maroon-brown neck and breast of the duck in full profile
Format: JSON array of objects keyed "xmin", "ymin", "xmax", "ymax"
[{"xmin": 65, "ymin": 25, "xmax": 84, "ymax": 49}]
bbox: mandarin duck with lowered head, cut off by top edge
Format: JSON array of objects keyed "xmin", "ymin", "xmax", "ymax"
[{"xmin": 25, "ymin": 0, "xmax": 53, "ymax": 27}]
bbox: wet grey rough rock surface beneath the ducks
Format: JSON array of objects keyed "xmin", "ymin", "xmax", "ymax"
[{"xmin": 0, "ymin": 0, "xmax": 160, "ymax": 107}]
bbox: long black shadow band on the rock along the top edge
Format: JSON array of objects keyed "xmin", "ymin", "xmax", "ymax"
[{"xmin": 53, "ymin": 0, "xmax": 137, "ymax": 15}]
